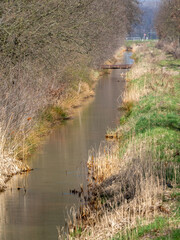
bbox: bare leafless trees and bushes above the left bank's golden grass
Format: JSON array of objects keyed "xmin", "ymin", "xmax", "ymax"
[{"xmin": 0, "ymin": 0, "xmax": 139, "ymax": 158}]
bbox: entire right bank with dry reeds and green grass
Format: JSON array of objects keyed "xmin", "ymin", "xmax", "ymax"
[{"xmin": 59, "ymin": 42, "xmax": 180, "ymax": 240}]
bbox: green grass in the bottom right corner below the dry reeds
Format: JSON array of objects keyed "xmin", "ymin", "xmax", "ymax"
[{"xmin": 111, "ymin": 189, "xmax": 180, "ymax": 240}]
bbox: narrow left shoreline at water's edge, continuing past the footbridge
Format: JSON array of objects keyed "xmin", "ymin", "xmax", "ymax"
[{"xmin": 0, "ymin": 48, "xmax": 124, "ymax": 193}]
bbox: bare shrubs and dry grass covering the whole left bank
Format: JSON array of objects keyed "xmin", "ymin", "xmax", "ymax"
[{"xmin": 0, "ymin": 0, "xmax": 139, "ymax": 188}]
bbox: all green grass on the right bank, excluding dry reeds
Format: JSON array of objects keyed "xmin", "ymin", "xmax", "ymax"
[{"xmin": 112, "ymin": 43, "xmax": 180, "ymax": 240}]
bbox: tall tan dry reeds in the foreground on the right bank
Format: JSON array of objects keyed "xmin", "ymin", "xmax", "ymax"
[{"xmin": 59, "ymin": 142, "xmax": 175, "ymax": 240}]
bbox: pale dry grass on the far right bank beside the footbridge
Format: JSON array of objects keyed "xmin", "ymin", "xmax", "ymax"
[{"xmin": 122, "ymin": 46, "xmax": 176, "ymax": 110}]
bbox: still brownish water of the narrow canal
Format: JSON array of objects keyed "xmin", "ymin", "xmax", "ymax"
[{"xmin": 0, "ymin": 53, "xmax": 132, "ymax": 240}]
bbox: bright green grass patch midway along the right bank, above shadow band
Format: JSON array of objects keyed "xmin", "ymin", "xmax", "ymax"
[{"xmin": 120, "ymin": 94, "xmax": 180, "ymax": 134}]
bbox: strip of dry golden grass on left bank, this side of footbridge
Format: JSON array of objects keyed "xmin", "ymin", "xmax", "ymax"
[{"xmin": 0, "ymin": 70, "xmax": 99, "ymax": 191}]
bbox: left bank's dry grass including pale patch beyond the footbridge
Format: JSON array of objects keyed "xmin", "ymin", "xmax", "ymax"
[{"xmin": 0, "ymin": 49, "xmax": 124, "ymax": 191}]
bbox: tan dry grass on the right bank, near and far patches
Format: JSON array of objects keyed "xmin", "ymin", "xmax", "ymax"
[{"xmin": 58, "ymin": 45, "xmax": 179, "ymax": 240}]
